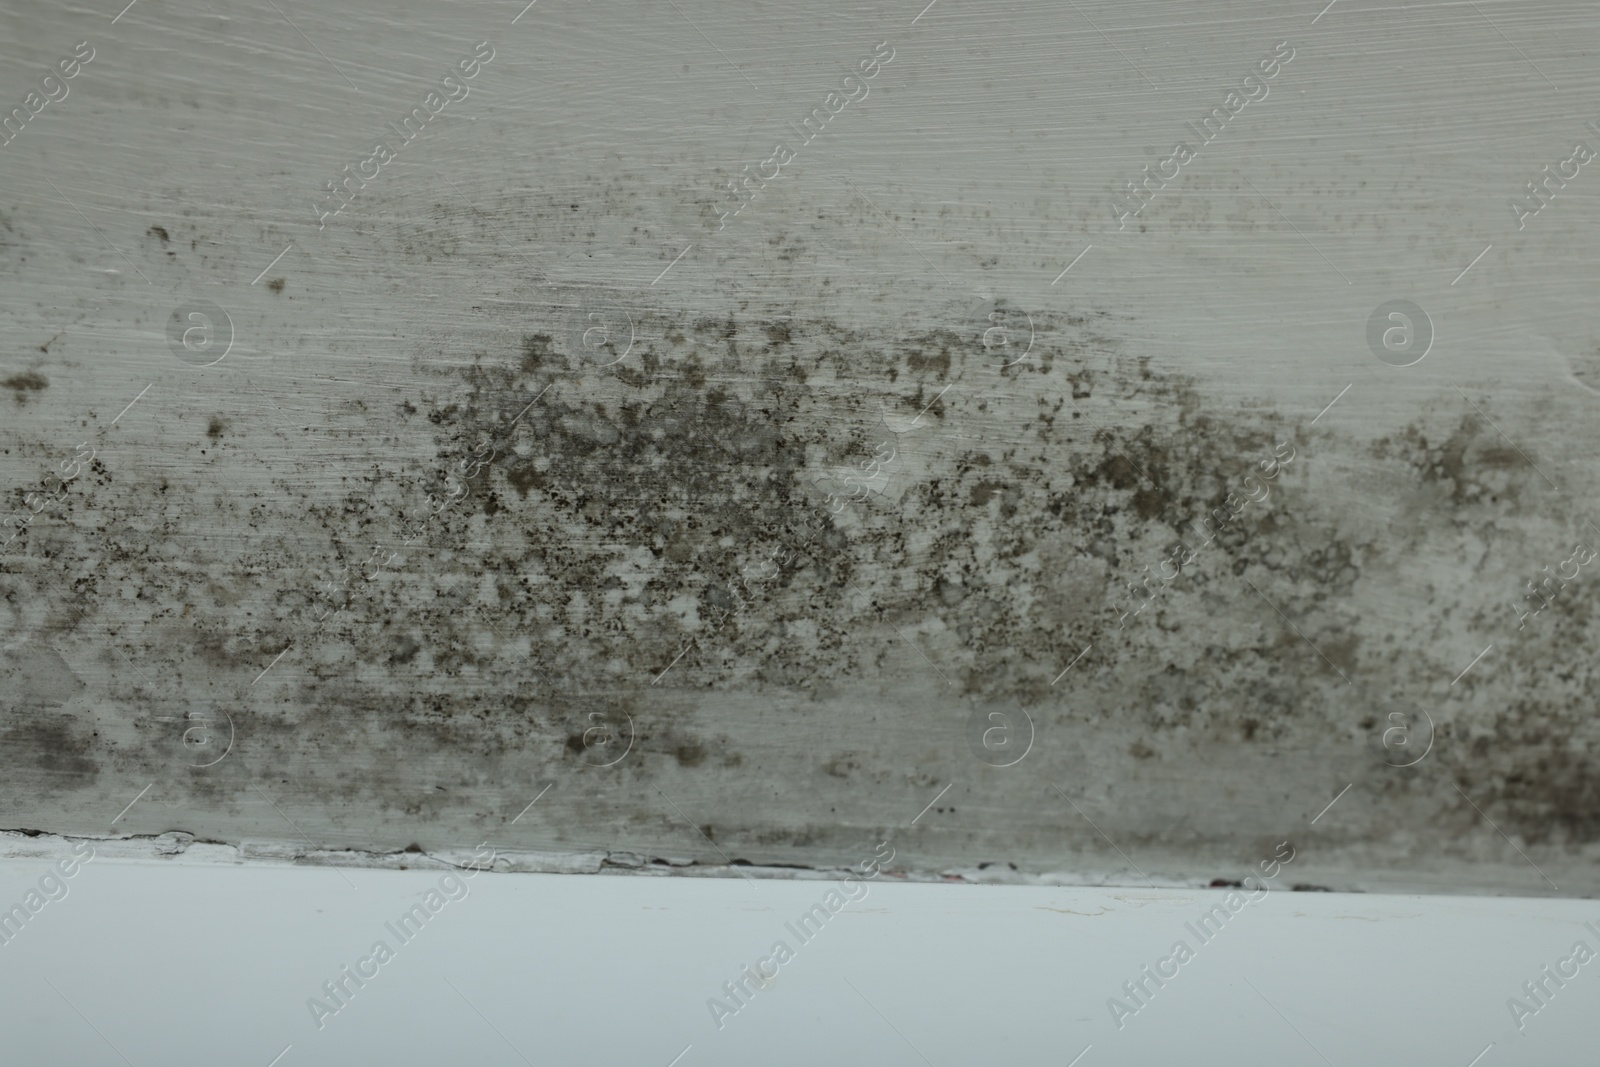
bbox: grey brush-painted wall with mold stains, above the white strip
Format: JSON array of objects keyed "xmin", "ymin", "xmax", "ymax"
[{"xmin": 0, "ymin": 0, "xmax": 1600, "ymax": 896}]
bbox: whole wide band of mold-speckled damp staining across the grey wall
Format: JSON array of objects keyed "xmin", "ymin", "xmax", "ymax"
[{"xmin": 11, "ymin": 286, "xmax": 1600, "ymax": 895}]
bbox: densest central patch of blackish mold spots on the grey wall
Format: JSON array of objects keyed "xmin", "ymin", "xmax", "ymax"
[{"xmin": 222, "ymin": 303, "xmax": 1354, "ymax": 742}]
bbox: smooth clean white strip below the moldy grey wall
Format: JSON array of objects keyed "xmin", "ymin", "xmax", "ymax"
[{"xmin": 0, "ymin": 843, "xmax": 1600, "ymax": 1067}]
